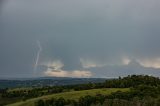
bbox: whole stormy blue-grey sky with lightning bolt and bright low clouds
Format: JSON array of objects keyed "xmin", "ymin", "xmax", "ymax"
[{"xmin": 0, "ymin": 0, "xmax": 160, "ymax": 78}]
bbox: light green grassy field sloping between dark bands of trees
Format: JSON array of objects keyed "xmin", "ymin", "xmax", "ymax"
[{"xmin": 7, "ymin": 88, "xmax": 129, "ymax": 106}]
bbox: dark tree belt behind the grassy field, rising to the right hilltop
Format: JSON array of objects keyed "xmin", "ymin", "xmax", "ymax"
[{"xmin": 0, "ymin": 75, "xmax": 160, "ymax": 99}]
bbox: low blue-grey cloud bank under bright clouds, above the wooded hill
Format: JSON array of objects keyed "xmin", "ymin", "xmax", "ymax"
[{"xmin": 90, "ymin": 61, "xmax": 160, "ymax": 77}]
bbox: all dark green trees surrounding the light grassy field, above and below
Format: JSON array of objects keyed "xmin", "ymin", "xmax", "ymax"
[{"xmin": 0, "ymin": 75, "xmax": 160, "ymax": 106}]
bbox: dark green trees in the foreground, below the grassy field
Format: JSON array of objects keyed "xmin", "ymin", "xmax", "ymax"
[{"xmin": 35, "ymin": 85, "xmax": 160, "ymax": 106}]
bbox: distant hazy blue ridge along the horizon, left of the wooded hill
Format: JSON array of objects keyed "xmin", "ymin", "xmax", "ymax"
[{"xmin": 0, "ymin": 77, "xmax": 107, "ymax": 88}]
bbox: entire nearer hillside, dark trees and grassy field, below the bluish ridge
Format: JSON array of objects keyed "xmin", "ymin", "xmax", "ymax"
[{"xmin": 1, "ymin": 75, "xmax": 160, "ymax": 106}]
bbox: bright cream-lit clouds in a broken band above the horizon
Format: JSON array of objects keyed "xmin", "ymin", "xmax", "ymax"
[{"xmin": 41, "ymin": 56, "xmax": 160, "ymax": 78}]
